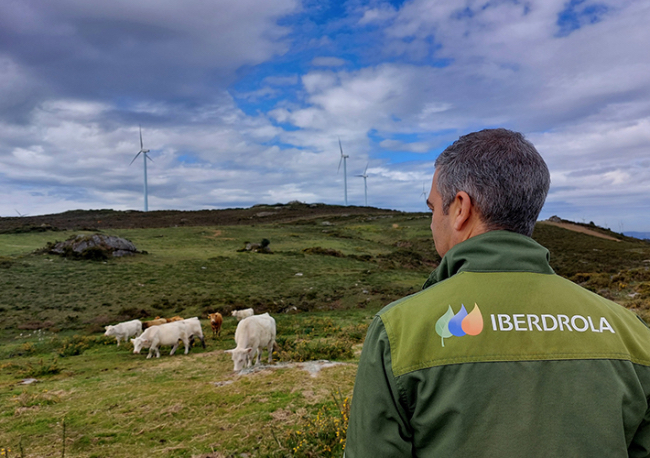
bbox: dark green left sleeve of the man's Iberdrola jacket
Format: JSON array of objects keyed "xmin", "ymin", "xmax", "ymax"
[{"xmin": 344, "ymin": 316, "xmax": 412, "ymax": 458}]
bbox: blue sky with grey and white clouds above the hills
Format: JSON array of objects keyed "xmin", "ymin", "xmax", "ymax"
[{"xmin": 0, "ymin": 0, "xmax": 650, "ymax": 232}]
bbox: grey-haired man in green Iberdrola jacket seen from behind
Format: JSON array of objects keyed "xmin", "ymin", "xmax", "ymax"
[{"xmin": 345, "ymin": 129, "xmax": 650, "ymax": 458}]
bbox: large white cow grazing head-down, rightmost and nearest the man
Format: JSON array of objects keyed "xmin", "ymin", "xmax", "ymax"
[{"xmin": 226, "ymin": 313, "xmax": 275, "ymax": 371}]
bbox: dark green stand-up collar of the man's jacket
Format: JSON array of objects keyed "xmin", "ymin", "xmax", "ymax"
[{"xmin": 422, "ymin": 231, "xmax": 554, "ymax": 289}]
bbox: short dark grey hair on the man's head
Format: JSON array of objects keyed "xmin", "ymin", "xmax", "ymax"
[{"xmin": 436, "ymin": 129, "xmax": 551, "ymax": 237}]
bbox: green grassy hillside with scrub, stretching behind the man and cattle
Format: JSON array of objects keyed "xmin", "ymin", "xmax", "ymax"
[{"xmin": 0, "ymin": 208, "xmax": 650, "ymax": 458}]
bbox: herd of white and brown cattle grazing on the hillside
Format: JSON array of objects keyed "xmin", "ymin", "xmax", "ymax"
[{"xmin": 104, "ymin": 308, "xmax": 275, "ymax": 371}]
